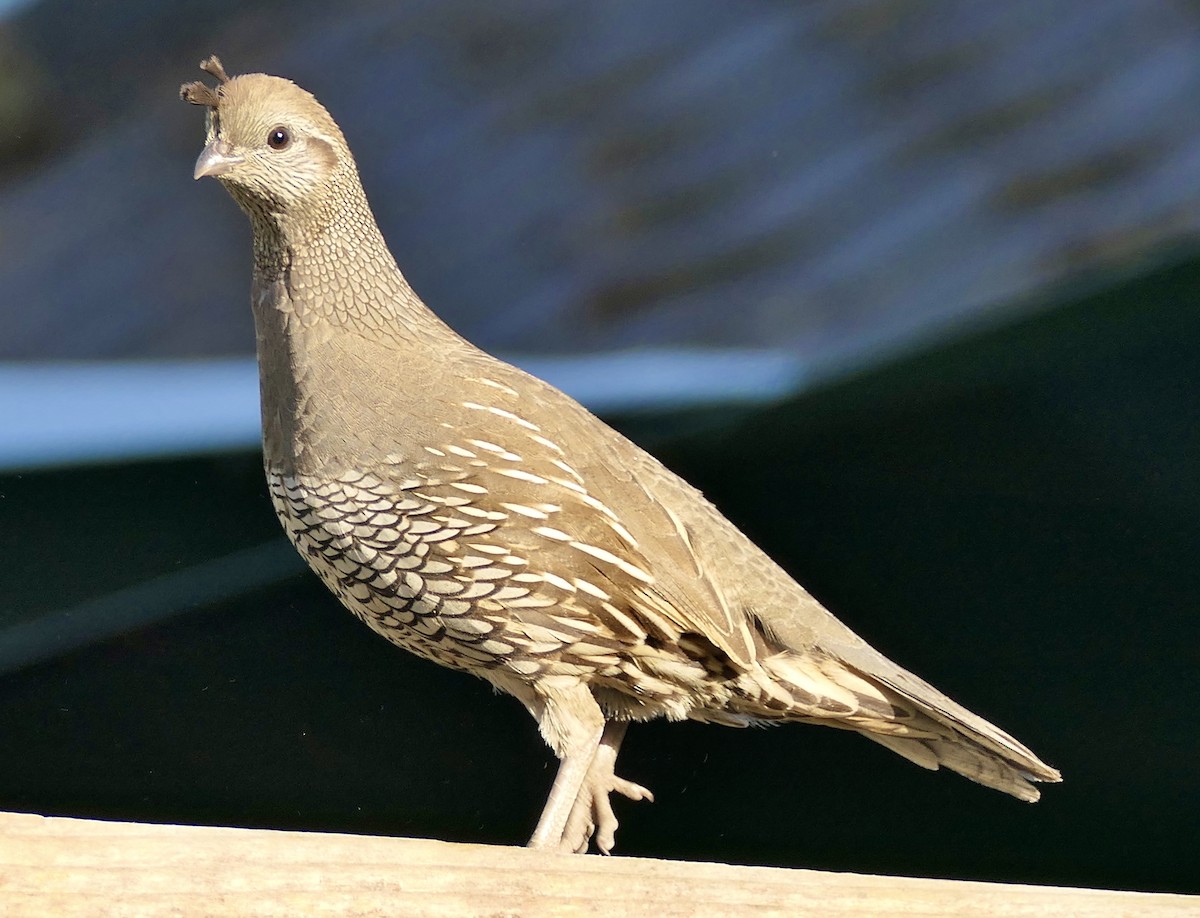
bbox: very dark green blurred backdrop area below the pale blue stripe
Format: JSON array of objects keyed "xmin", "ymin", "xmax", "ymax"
[{"xmin": 0, "ymin": 258, "xmax": 1200, "ymax": 893}]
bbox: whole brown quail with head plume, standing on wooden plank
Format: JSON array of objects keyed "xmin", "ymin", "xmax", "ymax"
[{"xmin": 182, "ymin": 58, "xmax": 1060, "ymax": 852}]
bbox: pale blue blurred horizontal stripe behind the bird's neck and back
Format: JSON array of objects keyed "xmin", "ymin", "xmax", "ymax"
[{"xmin": 0, "ymin": 349, "xmax": 805, "ymax": 470}]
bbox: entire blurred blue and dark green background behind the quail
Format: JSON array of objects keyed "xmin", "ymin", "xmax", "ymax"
[{"xmin": 0, "ymin": 0, "xmax": 1200, "ymax": 893}]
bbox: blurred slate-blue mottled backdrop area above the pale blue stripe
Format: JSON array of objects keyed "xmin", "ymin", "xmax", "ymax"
[{"xmin": 0, "ymin": 0, "xmax": 1200, "ymax": 364}]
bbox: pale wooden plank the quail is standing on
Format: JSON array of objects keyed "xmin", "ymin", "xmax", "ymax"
[{"xmin": 0, "ymin": 814, "xmax": 1200, "ymax": 918}]
